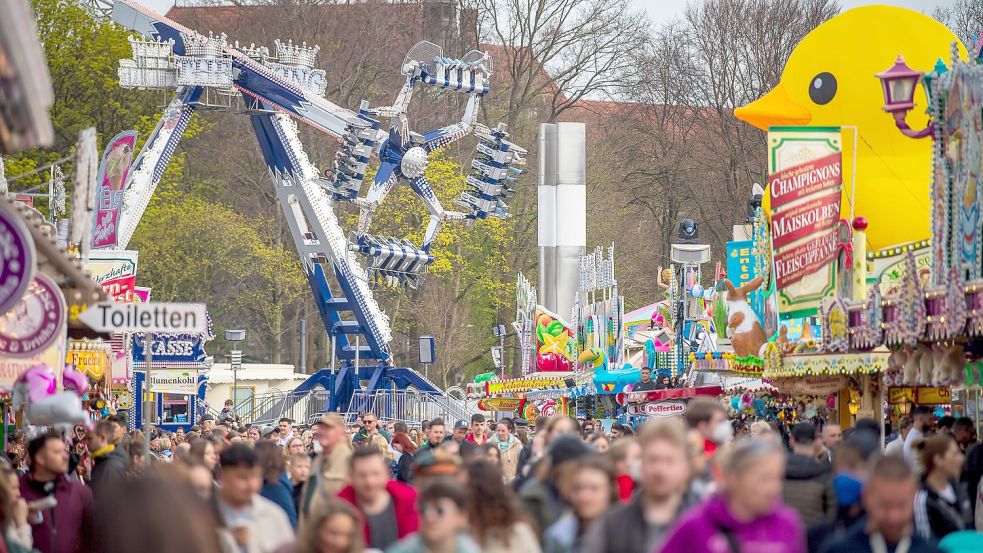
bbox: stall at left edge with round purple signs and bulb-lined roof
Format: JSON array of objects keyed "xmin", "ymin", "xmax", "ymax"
[{"xmin": 0, "ymin": 195, "xmax": 111, "ymax": 434}]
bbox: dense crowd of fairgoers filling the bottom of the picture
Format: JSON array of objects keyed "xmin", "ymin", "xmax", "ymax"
[{"xmin": 0, "ymin": 398, "xmax": 983, "ymax": 553}]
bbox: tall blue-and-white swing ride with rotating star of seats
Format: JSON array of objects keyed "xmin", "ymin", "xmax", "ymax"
[{"xmin": 89, "ymin": 0, "xmax": 526, "ymax": 409}]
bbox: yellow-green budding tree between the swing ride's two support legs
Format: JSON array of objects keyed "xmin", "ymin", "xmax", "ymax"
[{"xmin": 131, "ymin": 191, "xmax": 306, "ymax": 354}]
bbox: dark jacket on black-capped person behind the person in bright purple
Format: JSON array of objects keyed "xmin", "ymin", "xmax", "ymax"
[{"xmin": 782, "ymin": 453, "xmax": 836, "ymax": 526}]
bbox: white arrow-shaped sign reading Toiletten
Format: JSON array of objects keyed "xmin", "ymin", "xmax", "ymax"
[{"xmin": 79, "ymin": 303, "xmax": 208, "ymax": 334}]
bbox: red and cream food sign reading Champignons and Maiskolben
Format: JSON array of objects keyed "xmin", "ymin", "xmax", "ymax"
[{"xmin": 768, "ymin": 127, "xmax": 843, "ymax": 319}]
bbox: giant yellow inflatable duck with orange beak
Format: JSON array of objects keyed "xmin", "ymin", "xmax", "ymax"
[{"xmin": 734, "ymin": 6, "xmax": 966, "ymax": 251}]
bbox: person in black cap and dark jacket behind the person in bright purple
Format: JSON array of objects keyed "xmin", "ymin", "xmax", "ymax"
[{"xmin": 782, "ymin": 422, "xmax": 836, "ymax": 526}]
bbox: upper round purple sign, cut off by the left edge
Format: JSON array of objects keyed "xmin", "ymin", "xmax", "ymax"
[{"xmin": 0, "ymin": 203, "xmax": 36, "ymax": 315}]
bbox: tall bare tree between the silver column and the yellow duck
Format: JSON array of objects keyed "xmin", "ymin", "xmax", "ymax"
[{"xmin": 618, "ymin": 0, "xmax": 838, "ymax": 272}]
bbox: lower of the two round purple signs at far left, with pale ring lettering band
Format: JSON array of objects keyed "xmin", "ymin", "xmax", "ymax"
[{"xmin": 0, "ymin": 272, "xmax": 67, "ymax": 357}]
